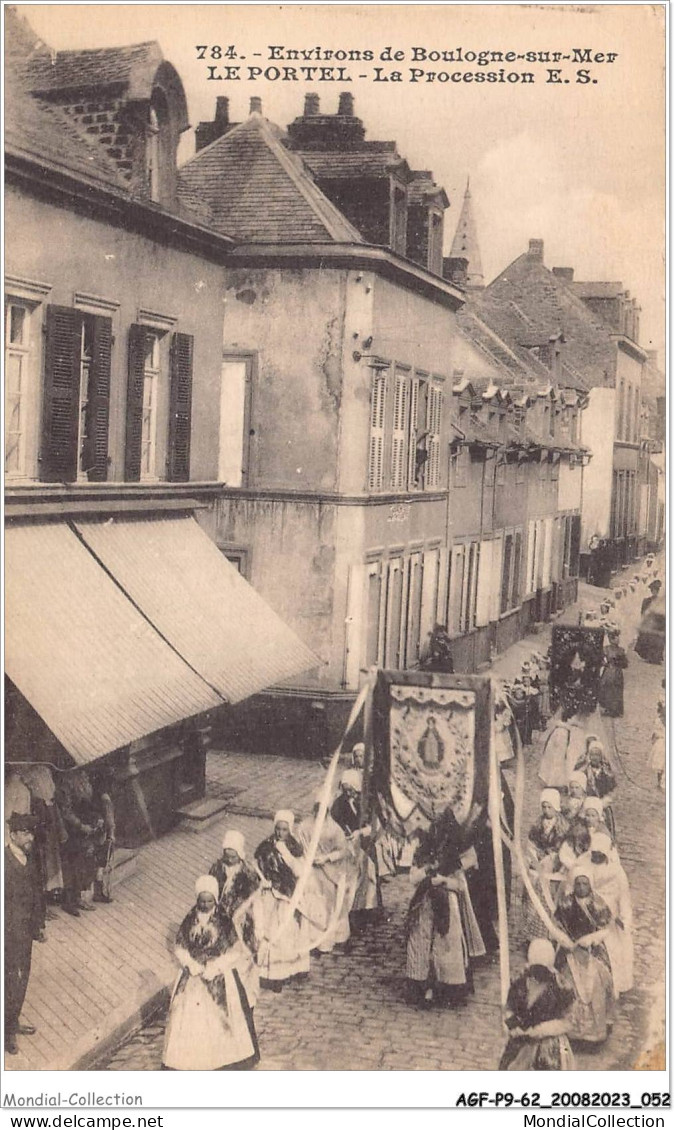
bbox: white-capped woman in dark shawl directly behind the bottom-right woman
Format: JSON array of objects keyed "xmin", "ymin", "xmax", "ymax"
[{"xmin": 555, "ymin": 864, "xmax": 615, "ymax": 1044}]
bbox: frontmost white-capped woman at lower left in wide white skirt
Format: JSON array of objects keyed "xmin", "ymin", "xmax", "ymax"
[{"xmin": 162, "ymin": 875, "xmax": 260, "ymax": 1071}]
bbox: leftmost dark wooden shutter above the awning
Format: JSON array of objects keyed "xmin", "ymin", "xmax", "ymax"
[{"xmin": 40, "ymin": 306, "xmax": 83, "ymax": 483}]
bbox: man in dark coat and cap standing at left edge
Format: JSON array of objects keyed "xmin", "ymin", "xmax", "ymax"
[{"xmin": 5, "ymin": 812, "xmax": 41, "ymax": 1055}]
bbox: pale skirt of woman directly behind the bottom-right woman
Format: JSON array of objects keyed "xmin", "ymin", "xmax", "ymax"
[{"xmin": 560, "ymin": 946, "xmax": 615, "ymax": 1044}]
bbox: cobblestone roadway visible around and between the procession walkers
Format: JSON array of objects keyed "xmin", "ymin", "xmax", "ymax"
[{"xmin": 97, "ymin": 632, "xmax": 665, "ymax": 1071}]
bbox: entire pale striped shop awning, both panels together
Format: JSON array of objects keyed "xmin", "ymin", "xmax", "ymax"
[{"xmin": 6, "ymin": 516, "xmax": 320, "ymax": 765}]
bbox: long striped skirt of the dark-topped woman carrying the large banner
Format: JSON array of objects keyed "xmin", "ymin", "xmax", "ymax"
[{"xmin": 407, "ymin": 890, "xmax": 469, "ymax": 985}]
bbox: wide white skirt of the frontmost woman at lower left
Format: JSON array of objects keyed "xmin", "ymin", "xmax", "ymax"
[{"xmin": 162, "ymin": 970, "xmax": 260, "ymax": 1071}]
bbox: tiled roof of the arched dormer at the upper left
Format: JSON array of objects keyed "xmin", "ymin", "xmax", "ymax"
[{"xmin": 27, "ymin": 42, "xmax": 163, "ymax": 97}]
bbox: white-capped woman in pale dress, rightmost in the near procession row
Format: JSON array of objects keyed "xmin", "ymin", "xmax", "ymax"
[{"xmin": 590, "ymin": 832, "xmax": 634, "ymax": 997}]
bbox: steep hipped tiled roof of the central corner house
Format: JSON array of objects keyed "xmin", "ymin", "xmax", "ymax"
[{"xmin": 179, "ymin": 113, "xmax": 363, "ymax": 243}]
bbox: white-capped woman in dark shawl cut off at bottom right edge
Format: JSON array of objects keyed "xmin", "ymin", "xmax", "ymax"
[{"xmin": 499, "ymin": 938, "xmax": 576, "ymax": 1071}]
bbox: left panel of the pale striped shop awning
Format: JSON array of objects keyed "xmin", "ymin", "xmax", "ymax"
[{"xmin": 5, "ymin": 522, "xmax": 221, "ymax": 765}]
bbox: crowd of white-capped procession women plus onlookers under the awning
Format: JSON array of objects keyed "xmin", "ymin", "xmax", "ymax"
[{"xmin": 6, "ymin": 563, "xmax": 665, "ymax": 1070}]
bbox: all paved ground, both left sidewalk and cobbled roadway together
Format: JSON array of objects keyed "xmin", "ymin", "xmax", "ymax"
[{"xmin": 7, "ymin": 590, "xmax": 665, "ymax": 1070}]
